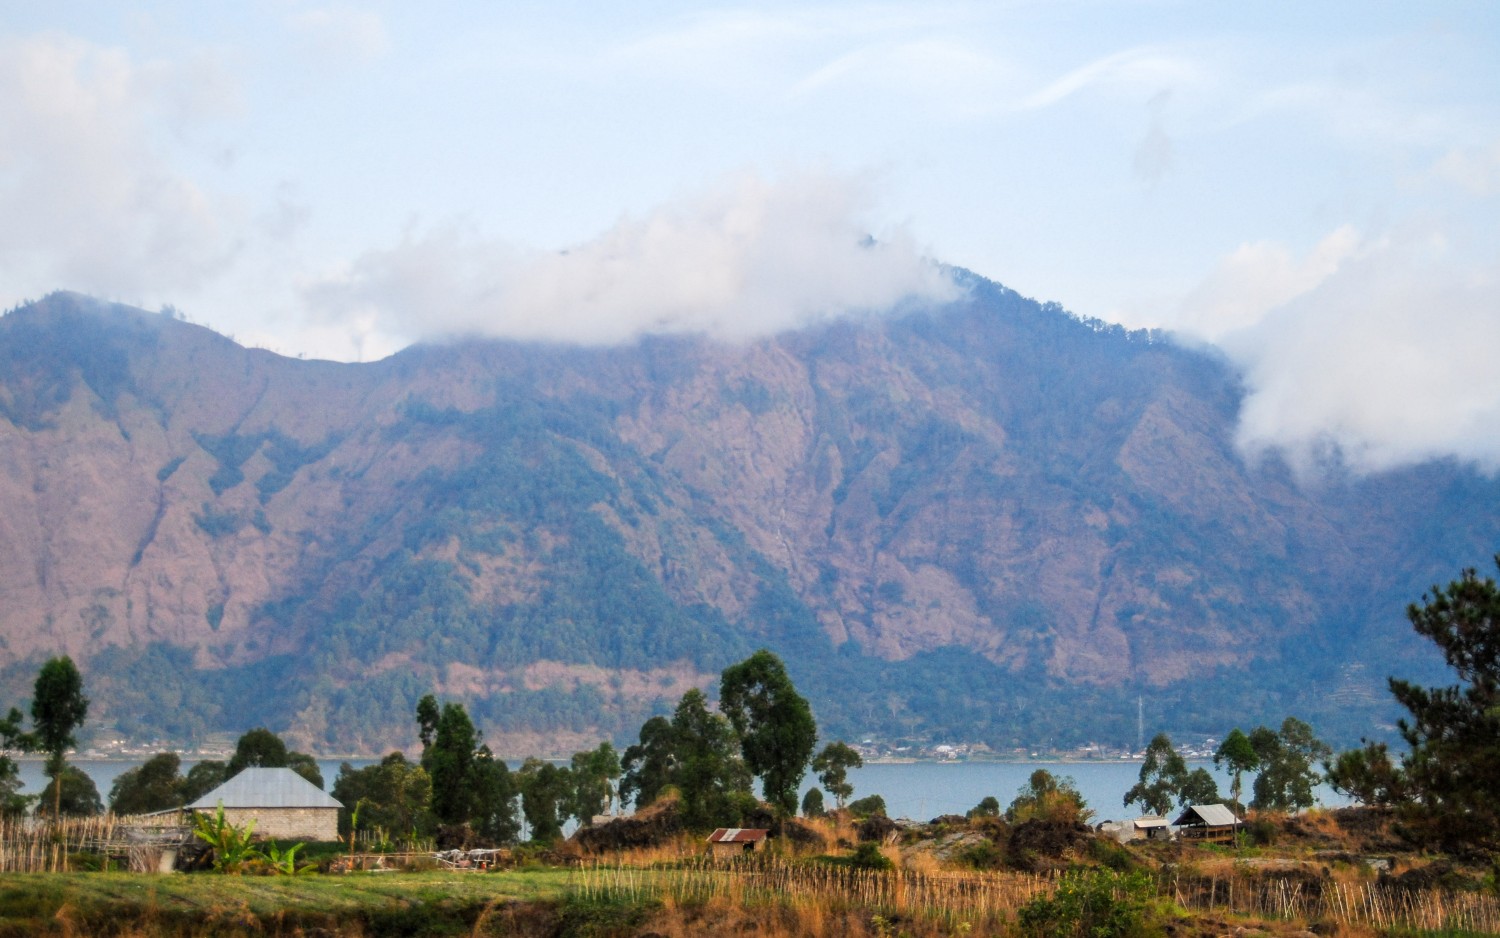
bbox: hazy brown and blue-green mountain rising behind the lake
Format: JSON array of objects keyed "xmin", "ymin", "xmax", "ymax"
[{"xmin": 0, "ymin": 276, "xmax": 1500, "ymax": 752}]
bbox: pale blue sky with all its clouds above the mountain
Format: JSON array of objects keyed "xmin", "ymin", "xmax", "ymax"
[{"xmin": 0, "ymin": 0, "xmax": 1500, "ymax": 473}]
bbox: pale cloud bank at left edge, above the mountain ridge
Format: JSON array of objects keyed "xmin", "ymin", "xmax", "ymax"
[{"xmin": 0, "ymin": 35, "xmax": 236, "ymax": 297}]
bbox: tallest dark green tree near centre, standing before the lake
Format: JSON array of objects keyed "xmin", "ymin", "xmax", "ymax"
[{"xmin": 719, "ymin": 648, "xmax": 818, "ymax": 816}]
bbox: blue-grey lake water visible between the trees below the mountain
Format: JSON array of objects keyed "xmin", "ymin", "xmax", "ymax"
[{"xmin": 21, "ymin": 759, "xmax": 1349, "ymax": 821}]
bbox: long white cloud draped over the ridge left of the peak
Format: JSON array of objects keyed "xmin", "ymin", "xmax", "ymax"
[{"xmin": 305, "ymin": 174, "xmax": 954, "ymax": 344}]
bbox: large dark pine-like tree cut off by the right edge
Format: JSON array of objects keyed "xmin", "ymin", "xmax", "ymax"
[{"xmin": 1329, "ymin": 555, "xmax": 1500, "ymax": 849}]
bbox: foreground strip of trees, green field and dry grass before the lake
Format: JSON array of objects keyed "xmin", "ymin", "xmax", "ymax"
[{"xmin": 0, "ymin": 557, "xmax": 1500, "ymax": 936}]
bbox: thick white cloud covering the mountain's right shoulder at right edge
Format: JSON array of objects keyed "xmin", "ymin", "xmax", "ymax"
[{"xmin": 1178, "ymin": 228, "xmax": 1500, "ymax": 471}]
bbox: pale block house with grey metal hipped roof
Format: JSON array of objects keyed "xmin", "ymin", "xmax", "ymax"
[{"xmin": 185, "ymin": 768, "xmax": 344, "ymax": 840}]
